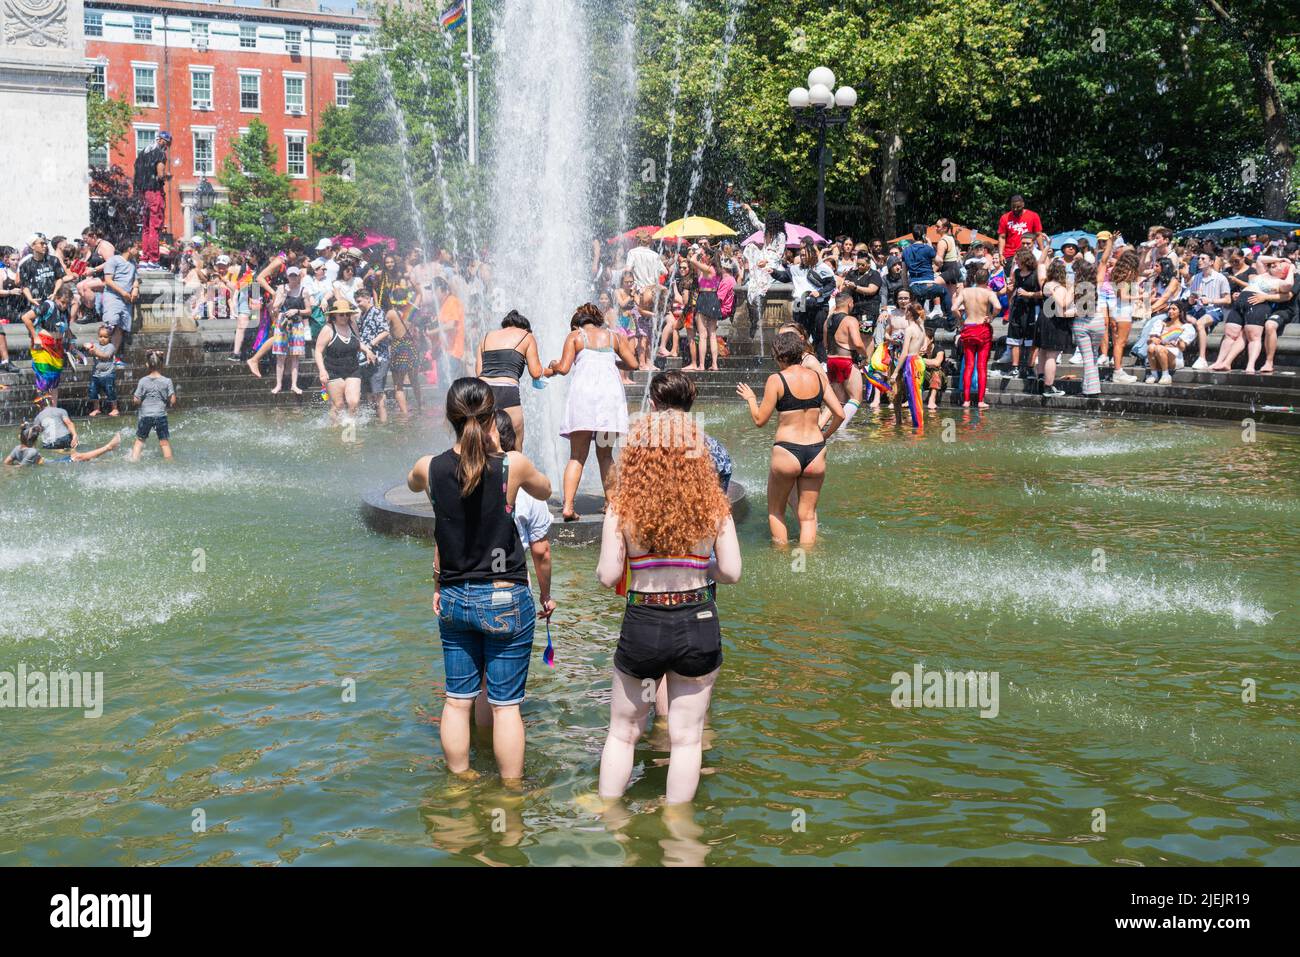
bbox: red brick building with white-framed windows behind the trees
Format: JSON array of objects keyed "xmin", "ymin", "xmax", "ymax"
[{"xmin": 85, "ymin": 0, "xmax": 372, "ymax": 237}]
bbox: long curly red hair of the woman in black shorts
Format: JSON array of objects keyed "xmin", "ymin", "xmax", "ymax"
[{"xmin": 610, "ymin": 410, "xmax": 731, "ymax": 555}]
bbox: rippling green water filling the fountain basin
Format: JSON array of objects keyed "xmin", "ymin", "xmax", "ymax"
[{"xmin": 0, "ymin": 404, "xmax": 1300, "ymax": 865}]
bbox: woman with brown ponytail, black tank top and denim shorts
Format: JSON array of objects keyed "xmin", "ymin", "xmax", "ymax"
[{"xmin": 407, "ymin": 378, "xmax": 555, "ymax": 785}]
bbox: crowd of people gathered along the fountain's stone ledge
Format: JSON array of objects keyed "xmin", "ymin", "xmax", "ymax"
[{"xmin": 0, "ymin": 187, "xmax": 1300, "ymax": 455}]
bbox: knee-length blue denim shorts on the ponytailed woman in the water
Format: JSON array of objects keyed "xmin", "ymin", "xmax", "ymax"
[{"xmin": 438, "ymin": 581, "xmax": 537, "ymax": 707}]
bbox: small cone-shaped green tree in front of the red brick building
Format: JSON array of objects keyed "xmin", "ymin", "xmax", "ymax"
[{"xmin": 212, "ymin": 120, "xmax": 297, "ymax": 247}]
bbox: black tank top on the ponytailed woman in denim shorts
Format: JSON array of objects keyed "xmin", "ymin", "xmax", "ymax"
[{"xmin": 429, "ymin": 449, "xmax": 528, "ymax": 585}]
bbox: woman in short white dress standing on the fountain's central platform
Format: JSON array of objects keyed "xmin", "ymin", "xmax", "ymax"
[{"xmin": 546, "ymin": 303, "xmax": 637, "ymax": 521}]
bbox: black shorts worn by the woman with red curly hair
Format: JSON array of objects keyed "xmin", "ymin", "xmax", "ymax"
[{"xmin": 614, "ymin": 601, "xmax": 723, "ymax": 681}]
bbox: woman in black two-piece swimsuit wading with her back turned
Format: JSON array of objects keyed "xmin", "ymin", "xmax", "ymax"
[{"xmin": 736, "ymin": 333, "xmax": 844, "ymax": 545}]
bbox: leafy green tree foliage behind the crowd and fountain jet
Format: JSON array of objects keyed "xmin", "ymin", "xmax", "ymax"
[{"xmin": 295, "ymin": 0, "xmax": 1300, "ymax": 252}]
